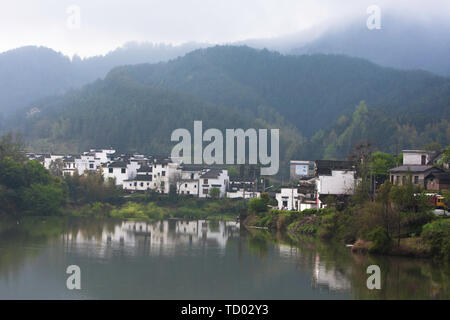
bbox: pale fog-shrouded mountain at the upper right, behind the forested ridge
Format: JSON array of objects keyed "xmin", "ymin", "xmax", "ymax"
[{"xmin": 288, "ymin": 15, "xmax": 450, "ymax": 76}]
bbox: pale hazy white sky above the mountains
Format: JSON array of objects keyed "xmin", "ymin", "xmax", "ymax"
[{"xmin": 0, "ymin": 0, "xmax": 450, "ymax": 57}]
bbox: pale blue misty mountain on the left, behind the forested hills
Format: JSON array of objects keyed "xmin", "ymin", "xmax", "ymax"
[{"xmin": 0, "ymin": 42, "xmax": 204, "ymax": 116}]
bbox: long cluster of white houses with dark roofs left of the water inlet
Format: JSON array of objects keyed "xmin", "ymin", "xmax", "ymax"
[{"xmin": 28, "ymin": 149, "xmax": 241, "ymax": 198}]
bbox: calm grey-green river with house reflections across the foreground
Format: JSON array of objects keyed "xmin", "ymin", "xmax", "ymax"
[{"xmin": 0, "ymin": 218, "xmax": 450, "ymax": 299}]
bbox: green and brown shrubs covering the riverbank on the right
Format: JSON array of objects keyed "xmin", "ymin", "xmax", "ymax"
[{"xmin": 244, "ymin": 186, "xmax": 450, "ymax": 261}]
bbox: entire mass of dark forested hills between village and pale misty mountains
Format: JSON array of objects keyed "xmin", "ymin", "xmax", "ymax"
[{"xmin": 10, "ymin": 46, "xmax": 450, "ymax": 160}]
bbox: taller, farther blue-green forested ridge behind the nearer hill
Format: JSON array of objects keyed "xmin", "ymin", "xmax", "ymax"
[{"xmin": 109, "ymin": 46, "xmax": 450, "ymax": 135}]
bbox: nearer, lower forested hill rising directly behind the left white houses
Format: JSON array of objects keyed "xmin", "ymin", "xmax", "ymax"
[{"xmin": 17, "ymin": 70, "xmax": 305, "ymax": 159}]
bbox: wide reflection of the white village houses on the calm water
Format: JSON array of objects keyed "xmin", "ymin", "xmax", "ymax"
[{"xmin": 61, "ymin": 220, "xmax": 240, "ymax": 257}]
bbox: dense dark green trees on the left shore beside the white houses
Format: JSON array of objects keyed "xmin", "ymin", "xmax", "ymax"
[{"xmin": 0, "ymin": 134, "xmax": 121, "ymax": 216}]
